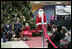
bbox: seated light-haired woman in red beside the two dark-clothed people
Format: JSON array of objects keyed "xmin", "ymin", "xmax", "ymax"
[{"xmin": 21, "ymin": 23, "xmax": 32, "ymax": 39}]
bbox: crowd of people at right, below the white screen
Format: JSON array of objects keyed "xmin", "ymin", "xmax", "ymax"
[{"xmin": 47, "ymin": 16, "xmax": 71, "ymax": 48}]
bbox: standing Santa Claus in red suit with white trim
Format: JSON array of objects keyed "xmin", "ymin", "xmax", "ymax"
[{"xmin": 36, "ymin": 8, "xmax": 47, "ymax": 35}]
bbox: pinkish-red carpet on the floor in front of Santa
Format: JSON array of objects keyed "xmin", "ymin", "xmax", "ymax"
[{"xmin": 24, "ymin": 37, "xmax": 47, "ymax": 48}]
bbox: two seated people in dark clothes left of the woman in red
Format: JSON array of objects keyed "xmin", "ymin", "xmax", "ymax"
[{"xmin": 3, "ymin": 20, "xmax": 22, "ymax": 42}]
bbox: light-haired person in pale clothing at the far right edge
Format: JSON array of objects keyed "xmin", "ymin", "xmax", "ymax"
[{"xmin": 61, "ymin": 26, "xmax": 71, "ymax": 47}]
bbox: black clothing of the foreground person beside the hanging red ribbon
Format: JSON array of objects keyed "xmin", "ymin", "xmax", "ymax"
[{"xmin": 48, "ymin": 32, "xmax": 65, "ymax": 48}]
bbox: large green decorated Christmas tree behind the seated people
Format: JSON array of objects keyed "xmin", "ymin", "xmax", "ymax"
[{"xmin": 1, "ymin": 1, "xmax": 35, "ymax": 29}]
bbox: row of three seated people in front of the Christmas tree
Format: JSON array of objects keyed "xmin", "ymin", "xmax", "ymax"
[{"xmin": 1, "ymin": 16, "xmax": 39, "ymax": 43}]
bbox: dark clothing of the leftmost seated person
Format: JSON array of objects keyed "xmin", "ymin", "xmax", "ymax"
[{"xmin": 3, "ymin": 24, "xmax": 12, "ymax": 42}]
